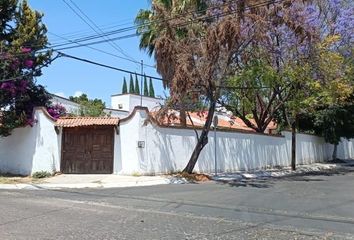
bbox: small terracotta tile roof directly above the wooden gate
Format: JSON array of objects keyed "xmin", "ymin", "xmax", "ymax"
[{"xmin": 55, "ymin": 117, "xmax": 119, "ymax": 127}]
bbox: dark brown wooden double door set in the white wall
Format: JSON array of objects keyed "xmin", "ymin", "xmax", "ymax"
[{"xmin": 61, "ymin": 126, "xmax": 114, "ymax": 174}]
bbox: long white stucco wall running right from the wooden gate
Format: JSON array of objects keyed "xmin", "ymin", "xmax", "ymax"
[{"xmin": 118, "ymin": 110, "xmax": 353, "ymax": 174}]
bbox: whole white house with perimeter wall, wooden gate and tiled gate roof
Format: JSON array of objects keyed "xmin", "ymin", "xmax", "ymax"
[{"xmin": 0, "ymin": 95, "xmax": 354, "ymax": 175}]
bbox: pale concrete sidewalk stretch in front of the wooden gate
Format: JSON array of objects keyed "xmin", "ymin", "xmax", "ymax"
[{"xmin": 0, "ymin": 174, "xmax": 171, "ymax": 189}]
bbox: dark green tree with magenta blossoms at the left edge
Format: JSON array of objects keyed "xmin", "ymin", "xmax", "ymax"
[{"xmin": 0, "ymin": 0, "xmax": 51, "ymax": 136}]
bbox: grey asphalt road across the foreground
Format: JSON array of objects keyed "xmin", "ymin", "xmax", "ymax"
[{"xmin": 0, "ymin": 169, "xmax": 354, "ymax": 240}]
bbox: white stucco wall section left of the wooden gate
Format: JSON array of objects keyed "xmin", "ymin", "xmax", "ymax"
[{"xmin": 0, "ymin": 109, "xmax": 60, "ymax": 175}]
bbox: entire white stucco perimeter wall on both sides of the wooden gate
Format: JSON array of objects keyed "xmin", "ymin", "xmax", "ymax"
[{"xmin": 0, "ymin": 109, "xmax": 354, "ymax": 175}]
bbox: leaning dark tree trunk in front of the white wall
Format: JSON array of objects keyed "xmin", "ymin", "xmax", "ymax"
[{"xmin": 183, "ymin": 99, "xmax": 216, "ymax": 173}]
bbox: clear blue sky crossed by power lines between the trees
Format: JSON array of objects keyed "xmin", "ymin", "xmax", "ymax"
[{"xmin": 28, "ymin": 0, "xmax": 167, "ymax": 107}]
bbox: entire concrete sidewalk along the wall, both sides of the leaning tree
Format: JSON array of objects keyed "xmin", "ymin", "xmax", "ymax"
[{"xmin": 0, "ymin": 160, "xmax": 354, "ymax": 189}]
